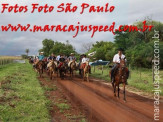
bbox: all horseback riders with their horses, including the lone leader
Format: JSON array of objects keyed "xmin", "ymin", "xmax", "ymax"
[{"xmin": 29, "ymin": 48, "xmax": 129, "ymax": 101}]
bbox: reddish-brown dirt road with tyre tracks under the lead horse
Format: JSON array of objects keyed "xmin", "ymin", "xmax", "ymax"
[{"xmin": 42, "ymin": 74, "xmax": 163, "ymax": 122}]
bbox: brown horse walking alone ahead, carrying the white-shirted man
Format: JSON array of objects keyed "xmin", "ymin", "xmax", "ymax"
[{"xmin": 110, "ymin": 58, "xmax": 128, "ymax": 101}]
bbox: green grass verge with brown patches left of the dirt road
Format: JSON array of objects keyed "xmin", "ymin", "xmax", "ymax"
[{"xmin": 0, "ymin": 63, "xmax": 50, "ymax": 122}]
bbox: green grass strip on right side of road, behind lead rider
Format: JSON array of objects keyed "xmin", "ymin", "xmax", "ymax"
[{"xmin": 91, "ymin": 67, "xmax": 163, "ymax": 95}]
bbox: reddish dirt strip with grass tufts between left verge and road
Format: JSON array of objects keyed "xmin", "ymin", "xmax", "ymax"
[{"xmin": 38, "ymin": 74, "xmax": 87, "ymax": 122}]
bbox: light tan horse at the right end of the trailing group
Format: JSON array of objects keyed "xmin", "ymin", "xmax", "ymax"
[{"xmin": 81, "ymin": 61, "xmax": 89, "ymax": 82}]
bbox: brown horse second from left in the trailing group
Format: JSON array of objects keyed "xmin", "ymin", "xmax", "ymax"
[{"xmin": 48, "ymin": 61, "xmax": 57, "ymax": 80}]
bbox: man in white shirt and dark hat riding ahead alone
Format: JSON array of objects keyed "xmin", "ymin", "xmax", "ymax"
[{"xmin": 111, "ymin": 48, "xmax": 129, "ymax": 84}]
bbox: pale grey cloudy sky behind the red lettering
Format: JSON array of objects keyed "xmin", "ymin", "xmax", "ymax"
[{"xmin": 0, "ymin": 0, "xmax": 163, "ymax": 55}]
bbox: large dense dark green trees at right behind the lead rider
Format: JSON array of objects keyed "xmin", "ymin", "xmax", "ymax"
[{"xmin": 114, "ymin": 20, "xmax": 163, "ymax": 68}]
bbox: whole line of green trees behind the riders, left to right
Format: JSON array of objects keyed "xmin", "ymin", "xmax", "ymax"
[{"xmin": 39, "ymin": 20, "xmax": 163, "ymax": 68}]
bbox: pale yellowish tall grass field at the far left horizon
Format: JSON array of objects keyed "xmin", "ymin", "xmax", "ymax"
[{"xmin": 0, "ymin": 56, "xmax": 21, "ymax": 66}]
